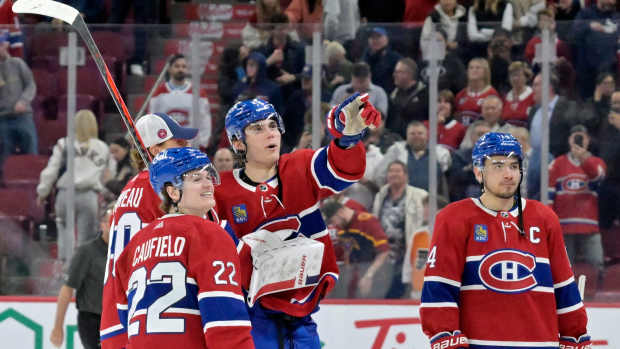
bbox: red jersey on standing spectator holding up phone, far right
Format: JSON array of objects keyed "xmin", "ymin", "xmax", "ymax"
[{"xmin": 549, "ymin": 155, "xmax": 607, "ymax": 234}]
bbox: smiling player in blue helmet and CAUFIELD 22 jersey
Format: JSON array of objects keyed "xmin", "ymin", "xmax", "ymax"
[{"xmin": 114, "ymin": 148, "xmax": 254, "ymax": 349}]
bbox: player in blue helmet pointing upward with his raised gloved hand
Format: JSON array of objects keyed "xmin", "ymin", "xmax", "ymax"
[{"xmin": 215, "ymin": 94, "xmax": 381, "ymax": 349}]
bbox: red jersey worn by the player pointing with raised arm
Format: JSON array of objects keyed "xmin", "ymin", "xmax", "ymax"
[{"xmin": 215, "ymin": 142, "xmax": 366, "ymax": 317}]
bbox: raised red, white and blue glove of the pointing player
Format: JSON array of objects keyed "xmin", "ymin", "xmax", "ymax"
[{"xmin": 327, "ymin": 93, "xmax": 381, "ymax": 147}]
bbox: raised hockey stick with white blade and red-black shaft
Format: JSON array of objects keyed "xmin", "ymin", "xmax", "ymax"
[{"xmin": 13, "ymin": 0, "xmax": 151, "ymax": 164}]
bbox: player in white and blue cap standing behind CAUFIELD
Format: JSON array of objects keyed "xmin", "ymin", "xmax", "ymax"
[{"xmin": 100, "ymin": 113, "xmax": 198, "ymax": 349}]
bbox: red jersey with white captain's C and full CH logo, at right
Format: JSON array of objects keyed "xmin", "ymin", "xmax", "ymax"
[{"xmin": 420, "ymin": 198, "xmax": 587, "ymax": 348}]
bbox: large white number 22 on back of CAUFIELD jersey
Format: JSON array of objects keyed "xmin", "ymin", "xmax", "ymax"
[{"xmin": 127, "ymin": 262, "xmax": 187, "ymax": 337}]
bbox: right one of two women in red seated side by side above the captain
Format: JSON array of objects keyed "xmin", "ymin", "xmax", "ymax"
[{"xmin": 502, "ymin": 62, "xmax": 534, "ymax": 128}]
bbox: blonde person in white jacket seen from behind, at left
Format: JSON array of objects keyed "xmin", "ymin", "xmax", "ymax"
[{"xmin": 37, "ymin": 110, "xmax": 110, "ymax": 262}]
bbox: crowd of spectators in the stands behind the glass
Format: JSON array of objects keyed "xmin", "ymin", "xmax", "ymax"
[{"xmin": 0, "ymin": 0, "xmax": 620, "ymax": 298}]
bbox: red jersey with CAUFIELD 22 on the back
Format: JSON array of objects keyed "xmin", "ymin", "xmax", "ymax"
[{"xmin": 114, "ymin": 214, "xmax": 254, "ymax": 349}]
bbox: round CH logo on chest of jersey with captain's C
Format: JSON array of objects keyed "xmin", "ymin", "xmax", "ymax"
[{"xmin": 478, "ymin": 249, "xmax": 538, "ymax": 293}]
